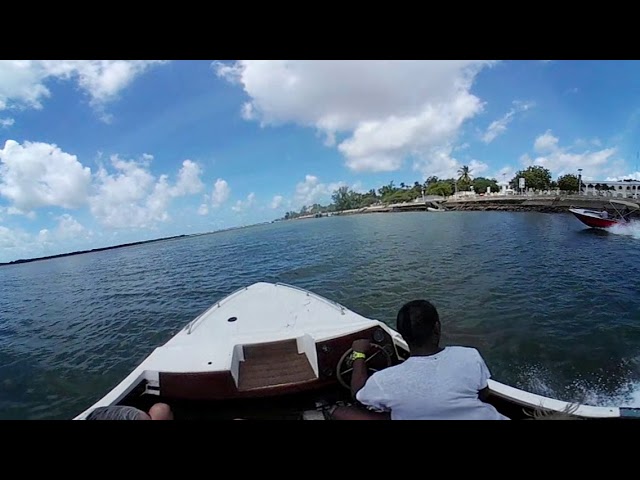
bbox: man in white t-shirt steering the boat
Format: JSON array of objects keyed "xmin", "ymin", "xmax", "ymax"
[{"xmin": 332, "ymin": 300, "xmax": 509, "ymax": 420}]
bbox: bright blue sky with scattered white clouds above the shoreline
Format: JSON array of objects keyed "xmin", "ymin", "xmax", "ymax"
[{"xmin": 0, "ymin": 60, "xmax": 640, "ymax": 262}]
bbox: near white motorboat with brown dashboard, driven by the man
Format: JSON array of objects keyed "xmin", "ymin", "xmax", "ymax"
[{"xmin": 75, "ymin": 282, "xmax": 640, "ymax": 420}]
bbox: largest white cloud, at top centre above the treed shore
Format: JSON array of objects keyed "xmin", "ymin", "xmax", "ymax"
[{"xmin": 214, "ymin": 60, "xmax": 494, "ymax": 172}]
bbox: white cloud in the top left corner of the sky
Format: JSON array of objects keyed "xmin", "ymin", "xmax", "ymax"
[{"xmin": 0, "ymin": 60, "xmax": 164, "ymax": 118}]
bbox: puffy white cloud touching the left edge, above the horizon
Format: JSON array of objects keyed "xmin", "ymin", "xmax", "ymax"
[{"xmin": 0, "ymin": 140, "xmax": 91, "ymax": 213}]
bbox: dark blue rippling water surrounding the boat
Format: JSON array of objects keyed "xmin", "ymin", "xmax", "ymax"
[{"xmin": 0, "ymin": 212, "xmax": 640, "ymax": 419}]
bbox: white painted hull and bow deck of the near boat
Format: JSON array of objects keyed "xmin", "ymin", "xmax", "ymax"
[{"xmin": 75, "ymin": 282, "xmax": 640, "ymax": 420}]
